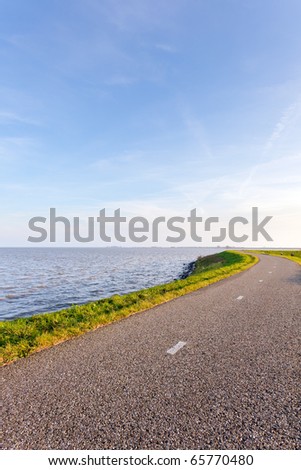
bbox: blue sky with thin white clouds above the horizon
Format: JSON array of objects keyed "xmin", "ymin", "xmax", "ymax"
[{"xmin": 0, "ymin": 0, "xmax": 301, "ymax": 247}]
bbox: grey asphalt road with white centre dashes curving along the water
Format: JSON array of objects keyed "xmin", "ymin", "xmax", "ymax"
[{"xmin": 1, "ymin": 256, "xmax": 301, "ymax": 450}]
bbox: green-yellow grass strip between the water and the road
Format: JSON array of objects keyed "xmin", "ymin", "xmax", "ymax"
[{"xmin": 0, "ymin": 251, "xmax": 258, "ymax": 365}]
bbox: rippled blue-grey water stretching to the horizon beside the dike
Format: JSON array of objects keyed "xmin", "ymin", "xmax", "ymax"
[{"xmin": 0, "ymin": 248, "xmax": 220, "ymax": 320}]
